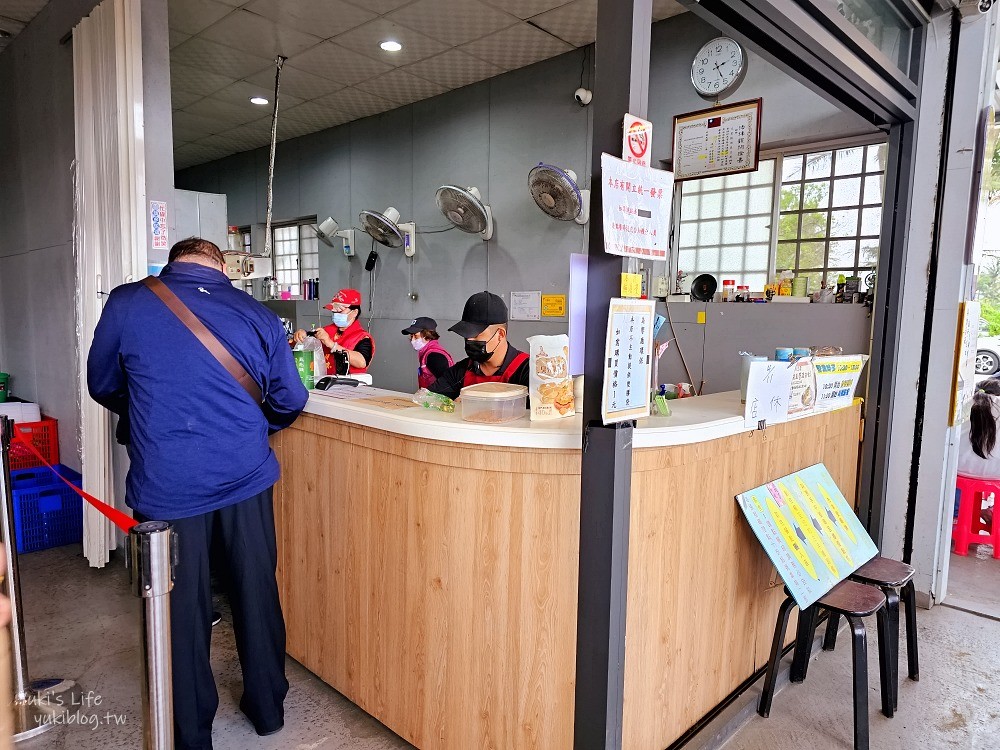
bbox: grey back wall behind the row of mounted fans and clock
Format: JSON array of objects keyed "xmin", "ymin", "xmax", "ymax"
[{"xmin": 177, "ymin": 14, "xmax": 880, "ymax": 390}]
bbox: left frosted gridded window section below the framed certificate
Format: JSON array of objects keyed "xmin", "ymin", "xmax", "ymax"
[{"xmin": 677, "ymin": 159, "xmax": 775, "ymax": 290}]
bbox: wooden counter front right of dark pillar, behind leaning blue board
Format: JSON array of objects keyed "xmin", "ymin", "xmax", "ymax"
[{"xmin": 623, "ymin": 407, "xmax": 860, "ymax": 750}]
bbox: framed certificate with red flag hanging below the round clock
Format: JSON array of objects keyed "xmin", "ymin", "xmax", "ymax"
[{"xmin": 673, "ymin": 99, "xmax": 762, "ymax": 182}]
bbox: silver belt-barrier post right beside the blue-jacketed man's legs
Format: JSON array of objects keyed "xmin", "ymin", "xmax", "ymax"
[{"xmin": 128, "ymin": 521, "xmax": 177, "ymax": 750}]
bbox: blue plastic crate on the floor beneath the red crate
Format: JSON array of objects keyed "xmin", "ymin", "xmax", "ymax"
[{"xmin": 11, "ymin": 465, "xmax": 83, "ymax": 554}]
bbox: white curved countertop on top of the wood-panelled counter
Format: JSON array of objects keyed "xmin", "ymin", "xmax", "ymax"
[{"xmin": 305, "ymin": 388, "xmax": 772, "ymax": 450}]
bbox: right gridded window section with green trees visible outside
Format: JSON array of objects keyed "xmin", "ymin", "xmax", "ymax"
[{"xmin": 776, "ymin": 143, "xmax": 886, "ymax": 291}]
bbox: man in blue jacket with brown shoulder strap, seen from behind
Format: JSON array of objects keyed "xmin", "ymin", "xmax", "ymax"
[{"xmin": 87, "ymin": 238, "xmax": 308, "ymax": 750}]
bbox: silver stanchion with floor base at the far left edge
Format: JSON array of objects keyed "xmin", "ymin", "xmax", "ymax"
[{"xmin": 0, "ymin": 417, "xmax": 80, "ymax": 742}]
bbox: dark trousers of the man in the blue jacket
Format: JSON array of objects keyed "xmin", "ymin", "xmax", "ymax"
[{"xmin": 136, "ymin": 488, "xmax": 288, "ymax": 750}]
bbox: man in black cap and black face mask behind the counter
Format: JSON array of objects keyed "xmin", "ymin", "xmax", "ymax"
[{"xmin": 430, "ymin": 292, "xmax": 528, "ymax": 398}]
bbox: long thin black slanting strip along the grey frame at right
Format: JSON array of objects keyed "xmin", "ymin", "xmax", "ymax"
[{"xmin": 903, "ymin": 10, "xmax": 962, "ymax": 563}]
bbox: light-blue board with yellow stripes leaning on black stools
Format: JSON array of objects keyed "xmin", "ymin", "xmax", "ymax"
[{"xmin": 736, "ymin": 464, "xmax": 878, "ymax": 609}]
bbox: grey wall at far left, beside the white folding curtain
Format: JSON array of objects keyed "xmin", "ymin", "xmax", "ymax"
[{"xmin": 0, "ymin": 0, "xmax": 97, "ymax": 468}]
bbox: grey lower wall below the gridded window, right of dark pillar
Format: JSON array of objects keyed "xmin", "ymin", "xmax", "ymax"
[{"xmin": 657, "ymin": 302, "xmax": 871, "ymax": 393}]
